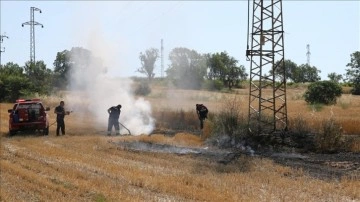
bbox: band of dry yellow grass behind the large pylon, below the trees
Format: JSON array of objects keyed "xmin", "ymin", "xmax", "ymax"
[{"xmin": 149, "ymin": 88, "xmax": 360, "ymax": 135}]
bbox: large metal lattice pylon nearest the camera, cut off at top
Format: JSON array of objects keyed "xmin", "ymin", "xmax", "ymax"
[{"xmin": 246, "ymin": 0, "xmax": 288, "ymax": 134}]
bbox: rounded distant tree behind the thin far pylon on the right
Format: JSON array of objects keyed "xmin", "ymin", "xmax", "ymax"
[{"xmin": 293, "ymin": 64, "xmax": 321, "ymax": 83}]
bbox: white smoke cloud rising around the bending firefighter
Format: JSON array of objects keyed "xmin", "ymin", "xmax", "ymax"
[{"xmin": 67, "ymin": 26, "xmax": 154, "ymax": 135}]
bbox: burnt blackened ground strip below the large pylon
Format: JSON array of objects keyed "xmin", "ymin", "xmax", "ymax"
[{"xmin": 112, "ymin": 141, "xmax": 360, "ymax": 180}]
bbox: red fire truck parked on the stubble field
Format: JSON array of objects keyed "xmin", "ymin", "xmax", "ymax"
[{"xmin": 8, "ymin": 99, "xmax": 50, "ymax": 136}]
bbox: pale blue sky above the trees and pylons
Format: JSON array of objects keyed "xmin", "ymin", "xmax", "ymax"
[{"xmin": 0, "ymin": 0, "xmax": 360, "ymax": 79}]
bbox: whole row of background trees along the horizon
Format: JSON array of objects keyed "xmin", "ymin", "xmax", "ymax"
[{"xmin": 0, "ymin": 47, "xmax": 360, "ymax": 102}]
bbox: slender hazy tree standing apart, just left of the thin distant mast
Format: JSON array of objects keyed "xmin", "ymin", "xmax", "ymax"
[{"xmin": 137, "ymin": 48, "xmax": 159, "ymax": 82}]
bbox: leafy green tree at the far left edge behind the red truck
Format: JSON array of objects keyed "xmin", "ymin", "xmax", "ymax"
[{"xmin": 0, "ymin": 62, "xmax": 30, "ymax": 102}]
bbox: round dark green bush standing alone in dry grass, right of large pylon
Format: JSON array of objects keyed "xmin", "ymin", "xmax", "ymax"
[{"xmin": 304, "ymin": 81, "xmax": 342, "ymax": 105}]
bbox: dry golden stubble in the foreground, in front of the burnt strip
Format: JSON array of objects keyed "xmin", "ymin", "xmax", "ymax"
[{"xmin": 0, "ymin": 134, "xmax": 360, "ymax": 201}]
